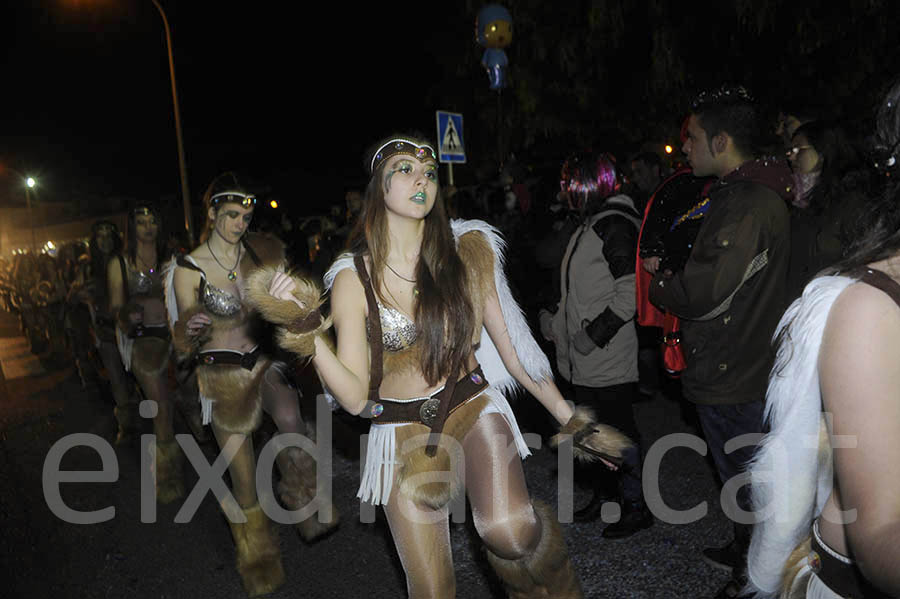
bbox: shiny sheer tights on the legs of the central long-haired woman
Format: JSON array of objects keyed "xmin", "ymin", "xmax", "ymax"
[{"xmin": 384, "ymin": 414, "xmax": 541, "ymax": 599}]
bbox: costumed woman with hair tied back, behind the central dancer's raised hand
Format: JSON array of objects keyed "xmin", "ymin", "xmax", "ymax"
[{"xmin": 166, "ymin": 173, "xmax": 337, "ymax": 596}]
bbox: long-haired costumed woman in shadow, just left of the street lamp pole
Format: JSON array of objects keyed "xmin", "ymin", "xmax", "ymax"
[{"xmin": 106, "ymin": 203, "xmax": 184, "ymax": 503}]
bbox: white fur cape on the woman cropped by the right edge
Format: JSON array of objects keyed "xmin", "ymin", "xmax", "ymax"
[{"xmin": 748, "ymin": 276, "xmax": 856, "ymax": 599}]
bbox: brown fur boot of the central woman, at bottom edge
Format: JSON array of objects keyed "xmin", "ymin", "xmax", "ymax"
[{"xmin": 487, "ymin": 502, "xmax": 584, "ymax": 599}]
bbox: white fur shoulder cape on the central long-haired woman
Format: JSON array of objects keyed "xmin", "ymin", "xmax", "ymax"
[{"xmin": 324, "ymin": 219, "xmax": 553, "ymax": 395}]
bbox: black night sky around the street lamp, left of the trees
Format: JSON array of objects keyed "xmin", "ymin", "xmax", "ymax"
[{"xmin": 0, "ymin": 0, "xmax": 464, "ymax": 213}]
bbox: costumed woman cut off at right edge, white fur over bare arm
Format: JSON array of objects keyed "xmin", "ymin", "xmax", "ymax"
[{"xmin": 748, "ymin": 83, "xmax": 900, "ymax": 599}]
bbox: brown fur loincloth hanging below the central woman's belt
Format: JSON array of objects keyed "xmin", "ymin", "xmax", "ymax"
[{"xmin": 395, "ymin": 394, "xmax": 488, "ymax": 509}]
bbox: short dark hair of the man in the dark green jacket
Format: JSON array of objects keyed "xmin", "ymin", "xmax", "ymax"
[{"xmin": 691, "ymin": 85, "xmax": 763, "ymax": 157}]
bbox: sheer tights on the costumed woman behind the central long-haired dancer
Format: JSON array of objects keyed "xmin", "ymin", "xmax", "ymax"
[{"xmin": 212, "ymin": 366, "xmax": 306, "ymax": 508}]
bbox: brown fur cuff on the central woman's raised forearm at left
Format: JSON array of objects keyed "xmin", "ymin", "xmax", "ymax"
[{"xmin": 244, "ymin": 268, "xmax": 331, "ymax": 357}]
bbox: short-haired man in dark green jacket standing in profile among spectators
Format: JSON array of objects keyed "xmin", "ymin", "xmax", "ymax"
[{"xmin": 650, "ymin": 87, "xmax": 791, "ymax": 597}]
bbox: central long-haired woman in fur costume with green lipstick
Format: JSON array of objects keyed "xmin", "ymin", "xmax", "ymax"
[{"xmin": 243, "ymin": 135, "xmax": 629, "ymax": 598}]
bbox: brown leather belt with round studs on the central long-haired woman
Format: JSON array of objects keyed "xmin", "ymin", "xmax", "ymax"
[{"xmin": 361, "ymin": 366, "xmax": 488, "ymax": 428}]
